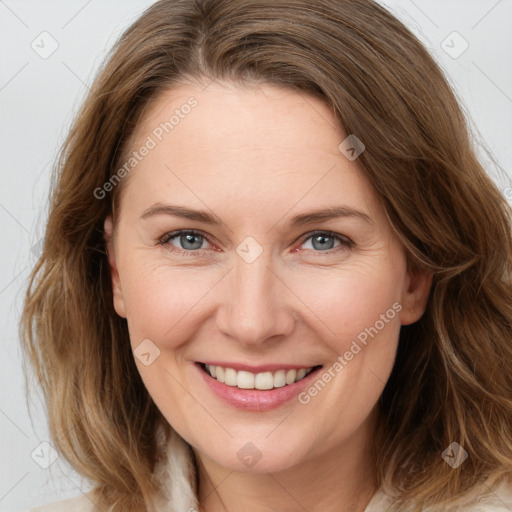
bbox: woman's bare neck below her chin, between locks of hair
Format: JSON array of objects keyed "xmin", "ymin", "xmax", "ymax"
[{"xmin": 194, "ymin": 410, "xmax": 377, "ymax": 512}]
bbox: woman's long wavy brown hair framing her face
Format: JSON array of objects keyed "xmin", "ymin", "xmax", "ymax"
[{"xmin": 20, "ymin": 0, "xmax": 512, "ymax": 511}]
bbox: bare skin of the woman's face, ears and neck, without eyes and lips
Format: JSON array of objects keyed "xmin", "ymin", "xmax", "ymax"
[{"xmin": 105, "ymin": 82, "xmax": 431, "ymax": 512}]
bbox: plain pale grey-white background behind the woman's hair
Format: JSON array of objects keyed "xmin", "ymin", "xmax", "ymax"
[{"xmin": 0, "ymin": 0, "xmax": 512, "ymax": 512}]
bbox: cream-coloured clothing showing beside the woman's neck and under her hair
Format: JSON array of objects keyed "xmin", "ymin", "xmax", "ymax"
[{"xmin": 30, "ymin": 434, "xmax": 512, "ymax": 512}]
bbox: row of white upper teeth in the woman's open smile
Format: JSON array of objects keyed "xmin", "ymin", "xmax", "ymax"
[{"xmin": 205, "ymin": 364, "xmax": 313, "ymax": 390}]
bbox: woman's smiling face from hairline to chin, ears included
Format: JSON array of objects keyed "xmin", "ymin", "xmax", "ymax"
[{"xmin": 105, "ymin": 82, "xmax": 429, "ymax": 472}]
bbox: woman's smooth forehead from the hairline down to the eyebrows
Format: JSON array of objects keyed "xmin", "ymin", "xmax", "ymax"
[{"xmin": 118, "ymin": 81, "xmax": 378, "ymax": 221}]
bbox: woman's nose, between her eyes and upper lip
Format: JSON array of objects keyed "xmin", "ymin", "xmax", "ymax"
[{"xmin": 217, "ymin": 252, "xmax": 296, "ymax": 347}]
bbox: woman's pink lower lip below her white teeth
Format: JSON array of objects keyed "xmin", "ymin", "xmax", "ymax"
[{"xmin": 196, "ymin": 363, "xmax": 321, "ymax": 412}]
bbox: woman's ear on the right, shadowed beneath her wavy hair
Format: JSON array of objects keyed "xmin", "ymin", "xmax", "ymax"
[{"xmin": 400, "ymin": 265, "xmax": 432, "ymax": 325}]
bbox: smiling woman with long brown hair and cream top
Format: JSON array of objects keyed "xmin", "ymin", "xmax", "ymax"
[{"xmin": 19, "ymin": 0, "xmax": 512, "ymax": 512}]
